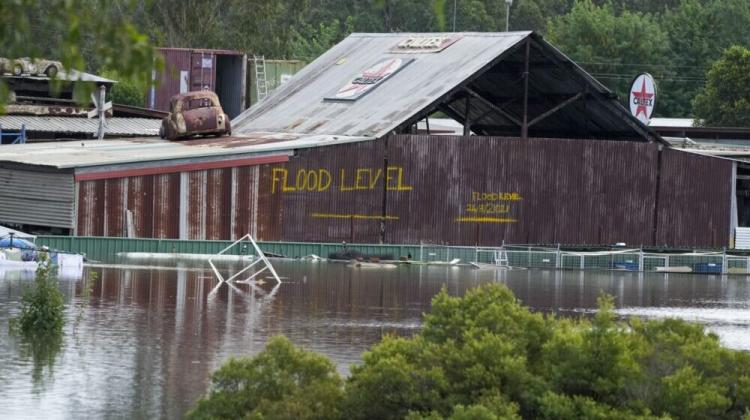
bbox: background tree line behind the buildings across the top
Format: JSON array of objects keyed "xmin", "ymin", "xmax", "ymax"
[{"xmin": 7, "ymin": 0, "xmax": 750, "ymax": 124}]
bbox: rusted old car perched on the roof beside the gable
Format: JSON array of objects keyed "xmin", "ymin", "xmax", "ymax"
[{"xmin": 159, "ymin": 90, "xmax": 232, "ymax": 140}]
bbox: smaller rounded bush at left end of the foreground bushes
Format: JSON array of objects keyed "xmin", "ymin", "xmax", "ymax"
[{"xmin": 188, "ymin": 337, "xmax": 343, "ymax": 420}]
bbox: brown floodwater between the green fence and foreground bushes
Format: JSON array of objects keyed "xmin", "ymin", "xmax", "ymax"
[{"xmin": 0, "ymin": 261, "xmax": 750, "ymax": 419}]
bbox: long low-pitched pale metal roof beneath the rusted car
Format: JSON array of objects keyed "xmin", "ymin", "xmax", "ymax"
[{"xmin": 0, "ymin": 133, "xmax": 370, "ymax": 169}]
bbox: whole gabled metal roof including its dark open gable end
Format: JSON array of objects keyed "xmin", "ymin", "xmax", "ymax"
[{"xmin": 232, "ymin": 32, "xmax": 659, "ymax": 140}]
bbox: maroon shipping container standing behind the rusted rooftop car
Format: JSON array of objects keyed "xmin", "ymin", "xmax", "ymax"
[{"xmin": 146, "ymin": 48, "xmax": 247, "ymax": 118}]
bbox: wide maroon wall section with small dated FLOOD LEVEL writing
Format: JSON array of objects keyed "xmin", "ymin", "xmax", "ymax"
[{"xmin": 386, "ymin": 136, "xmax": 657, "ymax": 245}]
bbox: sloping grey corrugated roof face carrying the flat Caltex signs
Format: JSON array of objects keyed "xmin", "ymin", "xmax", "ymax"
[{"xmin": 232, "ymin": 32, "xmax": 531, "ymax": 137}]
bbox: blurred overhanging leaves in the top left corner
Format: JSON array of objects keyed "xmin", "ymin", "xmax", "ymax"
[{"xmin": 0, "ymin": 0, "xmax": 161, "ymax": 104}]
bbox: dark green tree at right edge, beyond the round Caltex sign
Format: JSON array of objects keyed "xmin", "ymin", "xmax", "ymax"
[{"xmin": 693, "ymin": 46, "xmax": 750, "ymax": 127}]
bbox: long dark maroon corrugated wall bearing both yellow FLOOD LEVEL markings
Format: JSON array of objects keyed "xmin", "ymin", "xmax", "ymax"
[{"xmin": 245, "ymin": 135, "xmax": 733, "ymax": 247}]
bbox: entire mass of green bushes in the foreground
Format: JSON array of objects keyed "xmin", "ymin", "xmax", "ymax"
[{"xmin": 193, "ymin": 285, "xmax": 750, "ymax": 420}]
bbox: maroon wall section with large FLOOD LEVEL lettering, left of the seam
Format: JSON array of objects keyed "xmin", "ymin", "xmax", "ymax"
[{"xmin": 261, "ymin": 140, "xmax": 390, "ymax": 242}]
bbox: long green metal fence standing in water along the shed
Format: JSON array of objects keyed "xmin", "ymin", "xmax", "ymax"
[{"xmin": 36, "ymin": 236, "xmax": 750, "ymax": 274}]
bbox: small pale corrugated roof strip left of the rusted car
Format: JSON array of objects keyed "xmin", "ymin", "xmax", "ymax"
[{"xmin": 0, "ymin": 115, "xmax": 161, "ymax": 136}]
